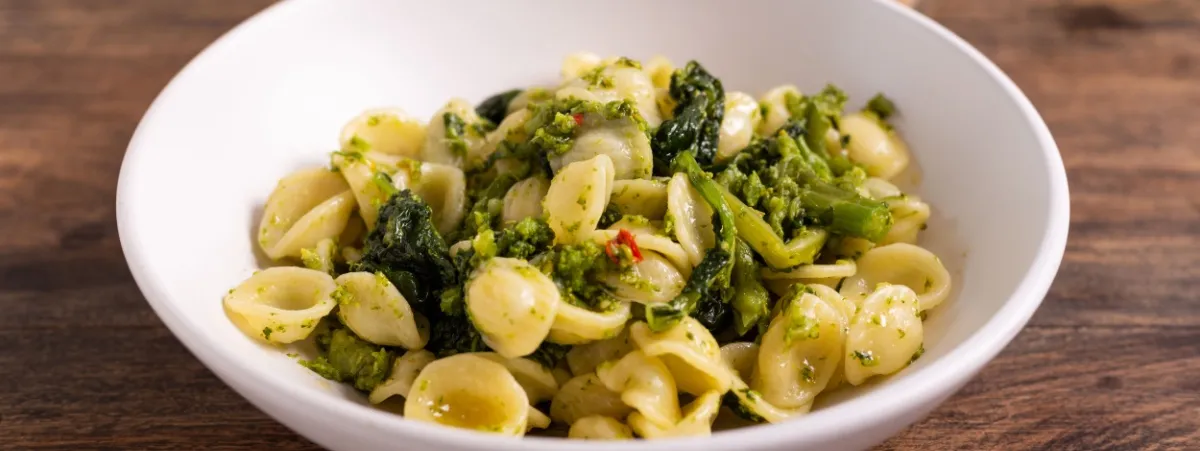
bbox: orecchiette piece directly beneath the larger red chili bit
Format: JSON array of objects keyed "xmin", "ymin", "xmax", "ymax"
[{"xmin": 604, "ymin": 251, "xmax": 688, "ymax": 303}]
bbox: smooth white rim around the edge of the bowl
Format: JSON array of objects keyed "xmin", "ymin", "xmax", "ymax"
[{"xmin": 116, "ymin": 0, "xmax": 1070, "ymax": 451}]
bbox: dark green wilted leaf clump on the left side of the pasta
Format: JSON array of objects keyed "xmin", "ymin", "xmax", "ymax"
[{"xmin": 350, "ymin": 190, "xmax": 458, "ymax": 314}]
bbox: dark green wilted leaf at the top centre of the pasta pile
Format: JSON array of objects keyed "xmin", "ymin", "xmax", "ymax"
[{"xmin": 652, "ymin": 61, "xmax": 725, "ymax": 170}]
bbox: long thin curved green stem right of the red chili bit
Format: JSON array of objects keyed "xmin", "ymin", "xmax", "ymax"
[{"xmin": 646, "ymin": 151, "xmax": 737, "ymax": 332}]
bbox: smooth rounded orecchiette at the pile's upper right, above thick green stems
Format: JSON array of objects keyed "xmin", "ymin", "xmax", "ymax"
[{"xmin": 838, "ymin": 113, "xmax": 908, "ymax": 179}]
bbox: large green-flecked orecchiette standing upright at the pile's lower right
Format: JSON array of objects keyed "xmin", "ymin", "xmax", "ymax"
[{"xmin": 752, "ymin": 291, "xmax": 846, "ymax": 408}]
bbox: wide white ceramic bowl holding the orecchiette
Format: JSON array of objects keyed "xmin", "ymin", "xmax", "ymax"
[{"xmin": 118, "ymin": 0, "xmax": 1069, "ymax": 451}]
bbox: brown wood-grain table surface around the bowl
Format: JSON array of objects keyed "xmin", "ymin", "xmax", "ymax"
[{"xmin": 0, "ymin": 0, "xmax": 1200, "ymax": 450}]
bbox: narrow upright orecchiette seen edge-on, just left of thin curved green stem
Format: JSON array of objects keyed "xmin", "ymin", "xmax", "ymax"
[{"xmin": 667, "ymin": 173, "xmax": 716, "ymax": 266}]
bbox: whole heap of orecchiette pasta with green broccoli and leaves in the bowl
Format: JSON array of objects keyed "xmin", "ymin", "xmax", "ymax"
[{"xmin": 224, "ymin": 50, "xmax": 950, "ymax": 439}]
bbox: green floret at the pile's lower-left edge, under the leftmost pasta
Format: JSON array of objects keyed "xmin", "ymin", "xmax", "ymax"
[{"xmin": 300, "ymin": 320, "xmax": 394, "ymax": 391}]
